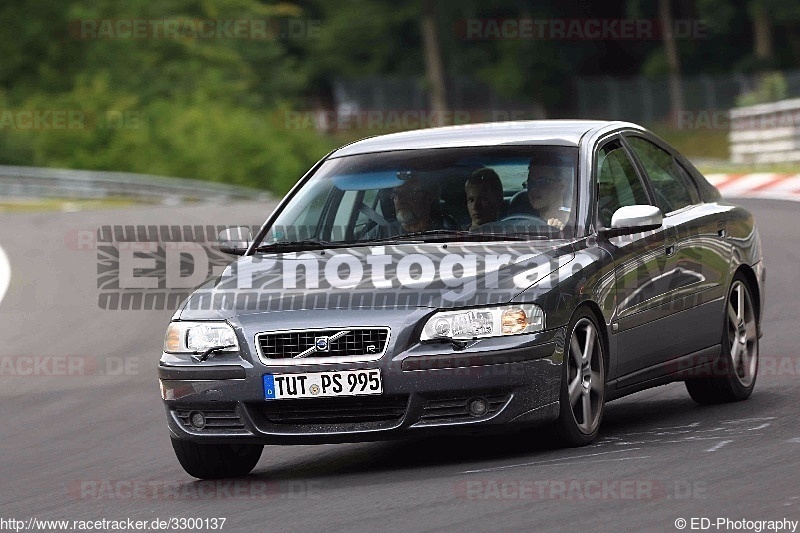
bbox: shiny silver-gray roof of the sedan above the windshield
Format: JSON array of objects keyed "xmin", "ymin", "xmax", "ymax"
[{"xmin": 331, "ymin": 120, "xmax": 642, "ymax": 157}]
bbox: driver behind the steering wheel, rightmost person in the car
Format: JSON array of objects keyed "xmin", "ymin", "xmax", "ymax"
[{"xmin": 526, "ymin": 154, "xmax": 573, "ymax": 230}]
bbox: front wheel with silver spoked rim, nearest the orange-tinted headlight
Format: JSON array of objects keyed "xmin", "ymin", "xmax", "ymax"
[{"xmin": 555, "ymin": 310, "xmax": 605, "ymax": 446}]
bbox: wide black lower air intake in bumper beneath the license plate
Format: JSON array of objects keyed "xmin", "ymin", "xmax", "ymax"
[{"xmin": 261, "ymin": 396, "xmax": 408, "ymax": 424}]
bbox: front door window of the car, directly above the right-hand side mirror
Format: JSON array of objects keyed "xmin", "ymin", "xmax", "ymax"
[{"xmin": 596, "ymin": 141, "xmax": 650, "ymax": 228}]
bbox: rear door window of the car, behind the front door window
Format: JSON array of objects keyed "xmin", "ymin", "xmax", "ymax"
[{"xmin": 626, "ymin": 137, "xmax": 694, "ymax": 213}]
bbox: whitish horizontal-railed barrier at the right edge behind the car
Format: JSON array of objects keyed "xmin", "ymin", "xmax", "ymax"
[{"xmin": 729, "ymin": 98, "xmax": 800, "ymax": 164}]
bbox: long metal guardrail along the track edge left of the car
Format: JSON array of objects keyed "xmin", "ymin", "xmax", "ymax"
[{"xmin": 0, "ymin": 166, "xmax": 271, "ymax": 204}]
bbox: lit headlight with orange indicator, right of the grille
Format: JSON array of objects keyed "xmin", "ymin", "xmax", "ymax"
[{"xmin": 420, "ymin": 304, "xmax": 544, "ymax": 341}]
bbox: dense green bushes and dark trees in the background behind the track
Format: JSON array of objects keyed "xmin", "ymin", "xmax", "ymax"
[{"xmin": 0, "ymin": 0, "xmax": 800, "ymax": 192}]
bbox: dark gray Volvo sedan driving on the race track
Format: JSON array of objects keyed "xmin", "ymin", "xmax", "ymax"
[{"xmin": 158, "ymin": 121, "xmax": 764, "ymax": 478}]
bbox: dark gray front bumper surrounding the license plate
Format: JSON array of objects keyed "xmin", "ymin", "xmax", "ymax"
[{"xmin": 159, "ymin": 328, "xmax": 564, "ymax": 444}]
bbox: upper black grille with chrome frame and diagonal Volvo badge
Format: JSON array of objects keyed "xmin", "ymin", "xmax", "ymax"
[{"xmin": 256, "ymin": 328, "xmax": 389, "ymax": 359}]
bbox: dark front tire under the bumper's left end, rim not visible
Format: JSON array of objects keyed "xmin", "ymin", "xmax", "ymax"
[{"xmin": 172, "ymin": 437, "xmax": 264, "ymax": 479}]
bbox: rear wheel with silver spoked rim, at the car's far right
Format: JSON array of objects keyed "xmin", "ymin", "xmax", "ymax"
[{"xmin": 686, "ymin": 274, "xmax": 758, "ymax": 405}]
